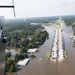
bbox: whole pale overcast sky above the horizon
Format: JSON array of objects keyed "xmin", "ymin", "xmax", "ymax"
[{"xmin": 0, "ymin": 0, "xmax": 75, "ymax": 18}]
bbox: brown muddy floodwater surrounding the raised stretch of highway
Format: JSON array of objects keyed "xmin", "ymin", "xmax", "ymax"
[{"xmin": 6, "ymin": 26, "xmax": 75, "ymax": 75}]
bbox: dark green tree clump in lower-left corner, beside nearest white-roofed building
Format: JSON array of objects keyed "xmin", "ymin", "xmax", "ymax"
[{"xmin": 5, "ymin": 52, "xmax": 28, "ymax": 72}]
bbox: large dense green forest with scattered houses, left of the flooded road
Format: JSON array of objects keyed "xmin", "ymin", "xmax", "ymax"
[{"xmin": 4, "ymin": 22, "xmax": 48, "ymax": 49}]
